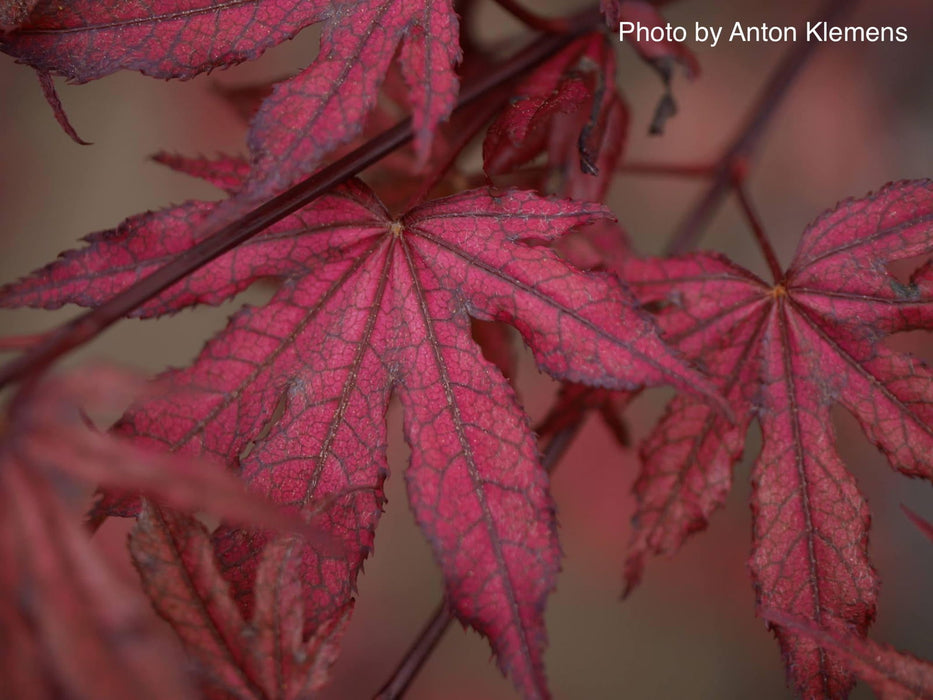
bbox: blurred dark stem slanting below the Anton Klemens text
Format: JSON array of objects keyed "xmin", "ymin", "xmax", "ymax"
[{"xmin": 665, "ymin": 0, "xmax": 855, "ymax": 255}]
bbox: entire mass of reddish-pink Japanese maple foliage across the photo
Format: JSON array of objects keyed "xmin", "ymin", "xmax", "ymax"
[{"xmin": 0, "ymin": 0, "xmax": 933, "ymax": 699}]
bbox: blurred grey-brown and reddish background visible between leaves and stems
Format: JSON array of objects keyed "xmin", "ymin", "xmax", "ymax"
[{"xmin": 0, "ymin": 0, "xmax": 933, "ymax": 700}]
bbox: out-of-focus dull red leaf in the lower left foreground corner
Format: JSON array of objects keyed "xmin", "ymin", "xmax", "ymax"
[{"xmin": 0, "ymin": 367, "xmax": 342, "ymax": 700}]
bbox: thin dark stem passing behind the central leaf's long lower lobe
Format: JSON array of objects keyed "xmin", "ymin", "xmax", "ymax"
[{"xmin": 373, "ymin": 420, "xmax": 583, "ymax": 700}]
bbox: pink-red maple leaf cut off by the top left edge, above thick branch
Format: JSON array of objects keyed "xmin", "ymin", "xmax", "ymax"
[{"xmin": 0, "ymin": 0, "xmax": 461, "ymax": 198}]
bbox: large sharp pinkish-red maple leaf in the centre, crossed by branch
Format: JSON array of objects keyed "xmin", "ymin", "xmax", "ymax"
[{"xmin": 2, "ymin": 157, "xmax": 709, "ymax": 696}]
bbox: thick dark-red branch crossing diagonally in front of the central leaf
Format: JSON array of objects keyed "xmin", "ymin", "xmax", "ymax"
[{"xmin": 0, "ymin": 5, "xmax": 601, "ymax": 388}]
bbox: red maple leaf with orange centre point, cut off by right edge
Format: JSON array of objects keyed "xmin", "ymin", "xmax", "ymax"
[{"xmin": 623, "ymin": 181, "xmax": 933, "ymax": 697}]
